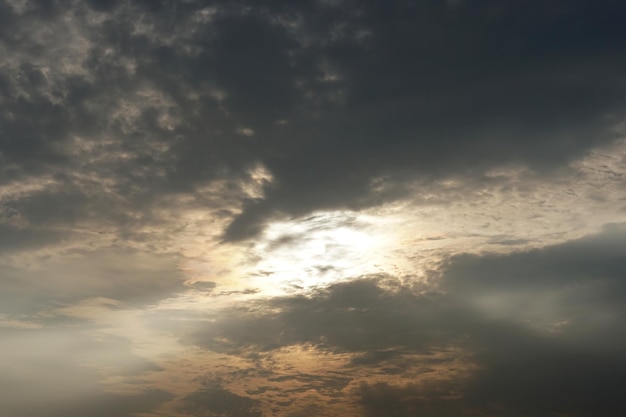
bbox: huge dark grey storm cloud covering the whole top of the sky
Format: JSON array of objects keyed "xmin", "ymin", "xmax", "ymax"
[{"xmin": 0, "ymin": 0, "xmax": 626, "ymax": 240}]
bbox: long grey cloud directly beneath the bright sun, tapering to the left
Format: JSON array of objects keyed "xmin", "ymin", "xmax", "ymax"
[{"xmin": 183, "ymin": 279, "xmax": 444, "ymax": 353}]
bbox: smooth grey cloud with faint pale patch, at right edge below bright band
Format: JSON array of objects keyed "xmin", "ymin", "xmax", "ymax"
[{"xmin": 442, "ymin": 224, "xmax": 626, "ymax": 334}]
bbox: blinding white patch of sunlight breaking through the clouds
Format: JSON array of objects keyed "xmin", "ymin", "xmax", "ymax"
[{"xmin": 247, "ymin": 212, "xmax": 387, "ymax": 294}]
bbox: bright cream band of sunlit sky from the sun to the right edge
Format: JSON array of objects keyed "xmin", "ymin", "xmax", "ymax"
[{"xmin": 177, "ymin": 138, "xmax": 624, "ymax": 306}]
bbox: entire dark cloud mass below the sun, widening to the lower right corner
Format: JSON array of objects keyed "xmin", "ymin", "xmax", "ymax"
[{"xmin": 188, "ymin": 225, "xmax": 626, "ymax": 417}]
